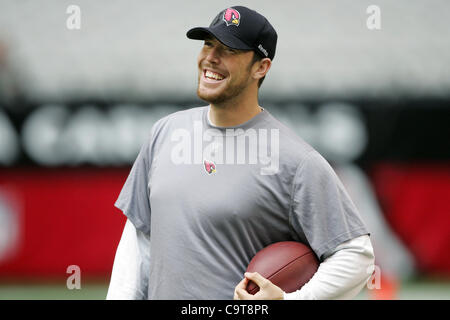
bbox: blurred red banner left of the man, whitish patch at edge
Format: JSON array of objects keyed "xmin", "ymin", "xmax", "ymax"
[{"xmin": 0, "ymin": 168, "xmax": 128, "ymax": 279}]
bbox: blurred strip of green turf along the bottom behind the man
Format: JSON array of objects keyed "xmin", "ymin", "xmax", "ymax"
[{"xmin": 0, "ymin": 280, "xmax": 450, "ymax": 300}]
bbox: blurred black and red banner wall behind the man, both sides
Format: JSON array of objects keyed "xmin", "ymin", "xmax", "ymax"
[{"xmin": 0, "ymin": 100, "xmax": 450, "ymax": 278}]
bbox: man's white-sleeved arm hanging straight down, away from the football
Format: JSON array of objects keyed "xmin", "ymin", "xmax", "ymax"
[{"xmin": 106, "ymin": 220, "xmax": 150, "ymax": 300}]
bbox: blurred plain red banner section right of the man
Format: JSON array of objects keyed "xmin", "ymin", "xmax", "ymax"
[{"xmin": 372, "ymin": 161, "xmax": 450, "ymax": 276}]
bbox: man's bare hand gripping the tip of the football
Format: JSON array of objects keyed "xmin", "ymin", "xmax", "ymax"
[{"xmin": 233, "ymin": 272, "xmax": 284, "ymax": 300}]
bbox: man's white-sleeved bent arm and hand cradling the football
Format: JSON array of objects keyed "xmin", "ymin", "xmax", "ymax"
[{"xmin": 235, "ymin": 235, "xmax": 375, "ymax": 300}]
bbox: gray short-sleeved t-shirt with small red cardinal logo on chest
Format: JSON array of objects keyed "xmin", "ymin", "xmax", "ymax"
[{"xmin": 115, "ymin": 106, "xmax": 368, "ymax": 299}]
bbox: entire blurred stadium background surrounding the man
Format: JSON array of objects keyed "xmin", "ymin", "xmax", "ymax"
[{"xmin": 0, "ymin": 0, "xmax": 450, "ymax": 299}]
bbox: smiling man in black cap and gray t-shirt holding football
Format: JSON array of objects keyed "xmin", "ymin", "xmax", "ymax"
[{"xmin": 107, "ymin": 6, "xmax": 374, "ymax": 299}]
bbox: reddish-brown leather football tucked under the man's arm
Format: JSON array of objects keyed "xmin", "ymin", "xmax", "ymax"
[{"xmin": 247, "ymin": 241, "xmax": 319, "ymax": 294}]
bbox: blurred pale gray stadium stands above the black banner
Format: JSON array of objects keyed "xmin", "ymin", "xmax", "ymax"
[{"xmin": 0, "ymin": 0, "xmax": 450, "ymax": 101}]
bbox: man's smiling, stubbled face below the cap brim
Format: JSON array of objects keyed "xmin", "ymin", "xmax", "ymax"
[{"xmin": 197, "ymin": 38, "xmax": 254, "ymax": 104}]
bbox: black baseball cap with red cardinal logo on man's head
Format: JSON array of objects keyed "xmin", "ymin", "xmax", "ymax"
[{"xmin": 186, "ymin": 6, "xmax": 278, "ymax": 60}]
